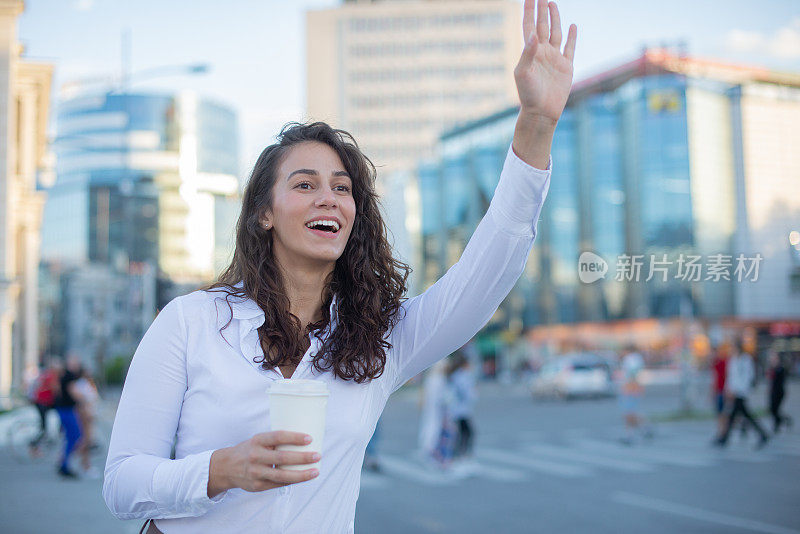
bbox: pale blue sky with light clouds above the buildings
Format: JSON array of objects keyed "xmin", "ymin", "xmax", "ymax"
[{"xmin": 18, "ymin": 0, "xmax": 800, "ymax": 178}]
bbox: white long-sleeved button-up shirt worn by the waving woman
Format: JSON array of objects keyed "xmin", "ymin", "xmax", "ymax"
[{"xmin": 103, "ymin": 144, "xmax": 550, "ymax": 534}]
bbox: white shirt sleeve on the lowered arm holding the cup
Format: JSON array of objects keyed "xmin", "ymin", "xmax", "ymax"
[{"xmin": 103, "ymin": 298, "xmax": 225, "ymax": 519}]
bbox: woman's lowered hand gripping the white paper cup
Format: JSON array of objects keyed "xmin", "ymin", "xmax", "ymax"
[{"xmin": 208, "ymin": 430, "xmax": 319, "ymax": 498}]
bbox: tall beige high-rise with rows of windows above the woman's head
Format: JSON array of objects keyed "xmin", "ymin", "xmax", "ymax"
[{"xmin": 306, "ymin": 0, "xmax": 522, "ymax": 179}]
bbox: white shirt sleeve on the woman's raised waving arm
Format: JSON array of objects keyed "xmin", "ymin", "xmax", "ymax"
[{"xmin": 386, "ymin": 144, "xmax": 551, "ymax": 393}]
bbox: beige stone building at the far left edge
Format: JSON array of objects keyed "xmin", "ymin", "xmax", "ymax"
[{"xmin": 0, "ymin": 0, "xmax": 53, "ymax": 406}]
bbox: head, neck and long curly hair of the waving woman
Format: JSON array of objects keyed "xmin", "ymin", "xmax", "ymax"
[{"xmin": 208, "ymin": 122, "xmax": 409, "ymax": 383}]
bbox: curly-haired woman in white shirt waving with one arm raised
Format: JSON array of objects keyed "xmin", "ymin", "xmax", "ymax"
[{"xmin": 103, "ymin": 0, "xmax": 577, "ymax": 534}]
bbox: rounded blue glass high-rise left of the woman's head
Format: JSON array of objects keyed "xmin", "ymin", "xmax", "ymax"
[{"xmin": 42, "ymin": 92, "xmax": 240, "ymax": 282}]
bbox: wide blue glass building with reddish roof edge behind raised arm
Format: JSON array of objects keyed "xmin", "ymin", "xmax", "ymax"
[{"xmin": 418, "ymin": 50, "xmax": 800, "ymax": 336}]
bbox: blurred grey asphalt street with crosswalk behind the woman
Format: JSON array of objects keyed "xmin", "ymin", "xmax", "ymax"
[{"xmin": 0, "ymin": 382, "xmax": 800, "ymax": 534}]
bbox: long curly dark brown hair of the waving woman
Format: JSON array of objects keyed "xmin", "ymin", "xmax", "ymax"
[{"xmin": 204, "ymin": 122, "xmax": 410, "ymax": 383}]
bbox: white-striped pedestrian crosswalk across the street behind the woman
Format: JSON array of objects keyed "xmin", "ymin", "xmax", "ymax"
[{"xmin": 361, "ymin": 431, "xmax": 800, "ymax": 491}]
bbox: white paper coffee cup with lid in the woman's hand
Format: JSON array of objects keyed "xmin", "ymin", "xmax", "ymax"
[{"xmin": 268, "ymin": 378, "xmax": 328, "ymax": 471}]
